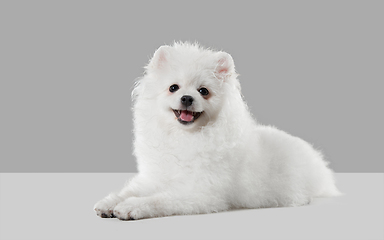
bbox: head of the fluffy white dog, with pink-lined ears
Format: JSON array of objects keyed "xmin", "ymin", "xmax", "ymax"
[{"xmin": 134, "ymin": 43, "xmax": 235, "ymax": 129}]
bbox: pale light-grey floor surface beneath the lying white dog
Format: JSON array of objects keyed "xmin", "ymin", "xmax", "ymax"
[{"xmin": 0, "ymin": 173, "xmax": 384, "ymax": 240}]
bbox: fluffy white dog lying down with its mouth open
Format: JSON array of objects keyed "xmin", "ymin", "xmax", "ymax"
[{"xmin": 95, "ymin": 43, "xmax": 339, "ymax": 220}]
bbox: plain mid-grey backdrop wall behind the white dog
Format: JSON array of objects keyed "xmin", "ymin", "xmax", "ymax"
[{"xmin": 0, "ymin": 1, "xmax": 384, "ymax": 172}]
